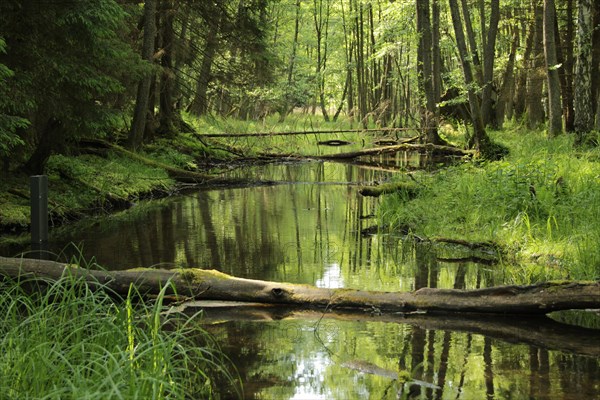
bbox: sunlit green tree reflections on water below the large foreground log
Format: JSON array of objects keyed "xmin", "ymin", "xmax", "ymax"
[{"xmin": 211, "ymin": 320, "xmax": 600, "ymax": 399}]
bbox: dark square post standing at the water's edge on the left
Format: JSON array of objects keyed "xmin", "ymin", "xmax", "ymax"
[{"xmin": 29, "ymin": 175, "xmax": 48, "ymax": 250}]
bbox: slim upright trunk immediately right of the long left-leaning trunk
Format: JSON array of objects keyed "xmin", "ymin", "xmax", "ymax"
[{"xmin": 481, "ymin": 0, "xmax": 500, "ymax": 125}]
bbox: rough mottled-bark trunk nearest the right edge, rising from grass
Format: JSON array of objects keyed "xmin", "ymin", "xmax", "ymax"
[{"xmin": 575, "ymin": 0, "xmax": 594, "ymax": 144}]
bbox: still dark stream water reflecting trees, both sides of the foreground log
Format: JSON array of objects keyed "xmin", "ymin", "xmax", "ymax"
[{"xmin": 2, "ymin": 162, "xmax": 600, "ymax": 399}]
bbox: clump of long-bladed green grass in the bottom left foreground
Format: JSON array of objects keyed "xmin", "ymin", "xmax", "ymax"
[{"xmin": 0, "ymin": 258, "xmax": 239, "ymax": 399}]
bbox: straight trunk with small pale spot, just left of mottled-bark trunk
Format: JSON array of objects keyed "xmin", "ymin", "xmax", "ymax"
[{"xmin": 544, "ymin": 0, "xmax": 562, "ymax": 136}]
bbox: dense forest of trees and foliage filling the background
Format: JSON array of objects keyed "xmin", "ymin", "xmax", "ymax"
[{"xmin": 0, "ymin": 0, "xmax": 600, "ymax": 173}]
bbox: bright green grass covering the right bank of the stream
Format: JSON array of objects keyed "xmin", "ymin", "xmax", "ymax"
[{"xmin": 380, "ymin": 129, "xmax": 600, "ymax": 283}]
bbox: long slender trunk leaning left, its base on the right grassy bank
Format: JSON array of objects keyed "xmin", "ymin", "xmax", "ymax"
[{"xmin": 450, "ymin": 0, "xmax": 491, "ymax": 155}]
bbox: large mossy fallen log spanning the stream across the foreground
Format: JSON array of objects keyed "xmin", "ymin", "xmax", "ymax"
[{"xmin": 0, "ymin": 257, "xmax": 600, "ymax": 314}]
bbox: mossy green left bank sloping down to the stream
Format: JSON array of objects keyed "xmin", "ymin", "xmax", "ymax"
[{"xmin": 0, "ymin": 116, "xmax": 366, "ymax": 240}]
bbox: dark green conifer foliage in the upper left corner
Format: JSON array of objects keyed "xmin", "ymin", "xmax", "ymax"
[{"xmin": 0, "ymin": 0, "xmax": 142, "ymax": 168}]
